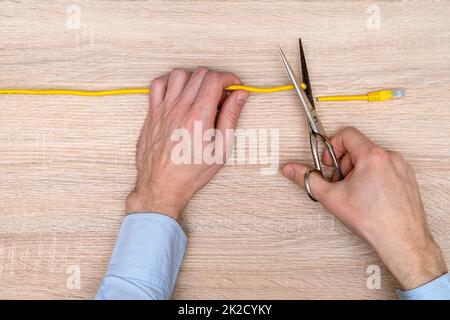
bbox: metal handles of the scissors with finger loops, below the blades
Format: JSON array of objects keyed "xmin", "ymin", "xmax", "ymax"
[{"xmin": 304, "ymin": 126, "xmax": 344, "ymax": 201}]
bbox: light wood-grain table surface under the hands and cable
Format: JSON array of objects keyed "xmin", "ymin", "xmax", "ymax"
[{"xmin": 0, "ymin": 0, "xmax": 450, "ymax": 299}]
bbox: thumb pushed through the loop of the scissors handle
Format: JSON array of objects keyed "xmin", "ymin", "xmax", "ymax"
[{"xmin": 282, "ymin": 163, "xmax": 333, "ymax": 202}]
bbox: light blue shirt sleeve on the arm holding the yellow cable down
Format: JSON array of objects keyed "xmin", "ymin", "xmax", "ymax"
[{"xmin": 96, "ymin": 213, "xmax": 187, "ymax": 300}]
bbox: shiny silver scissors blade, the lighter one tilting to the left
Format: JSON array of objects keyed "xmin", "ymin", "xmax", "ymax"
[{"xmin": 278, "ymin": 45, "xmax": 325, "ymax": 136}]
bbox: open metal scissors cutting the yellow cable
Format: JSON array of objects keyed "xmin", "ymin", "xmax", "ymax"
[{"xmin": 278, "ymin": 39, "xmax": 344, "ymax": 201}]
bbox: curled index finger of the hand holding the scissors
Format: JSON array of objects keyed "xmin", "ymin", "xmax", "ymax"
[{"xmin": 322, "ymin": 127, "xmax": 374, "ymax": 167}]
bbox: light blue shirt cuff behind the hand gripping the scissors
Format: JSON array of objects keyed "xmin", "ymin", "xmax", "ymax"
[{"xmin": 397, "ymin": 273, "xmax": 450, "ymax": 300}]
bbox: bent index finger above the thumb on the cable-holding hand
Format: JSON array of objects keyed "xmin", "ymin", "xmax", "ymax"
[{"xmin": 193, "ymin": 71, "xmax": 240, "ymax": 121}]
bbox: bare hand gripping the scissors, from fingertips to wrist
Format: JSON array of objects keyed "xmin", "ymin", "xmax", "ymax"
[{"xmin": 283, "ymin": 128, "xmax": 447, "ymax": 290}]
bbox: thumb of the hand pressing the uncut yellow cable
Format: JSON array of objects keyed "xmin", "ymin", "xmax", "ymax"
[{"xmin": 217, "ymin": 90, "xmax": 249, "ymax": 161}]
